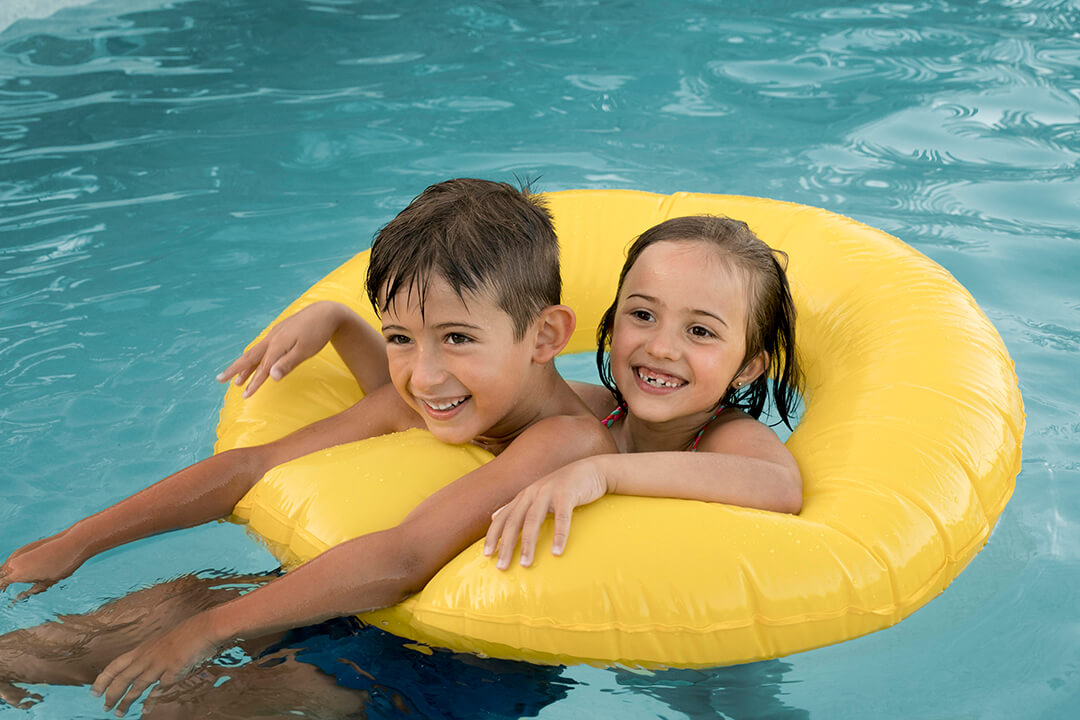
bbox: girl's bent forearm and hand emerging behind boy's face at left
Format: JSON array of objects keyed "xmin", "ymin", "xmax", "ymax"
[{"xmin": 217, "ymin": 300, "xmax": 390, "ymax": 397}]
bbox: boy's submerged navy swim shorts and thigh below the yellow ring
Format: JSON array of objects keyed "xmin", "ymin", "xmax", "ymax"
[{"xmin": 199, "ymin": 619, "xmax": 578, "ymax": 720}]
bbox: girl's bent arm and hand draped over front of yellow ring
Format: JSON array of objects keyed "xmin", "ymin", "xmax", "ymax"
[{"xmin": 484, "ymin": 416, "xmax": 802, "ymax": 570}]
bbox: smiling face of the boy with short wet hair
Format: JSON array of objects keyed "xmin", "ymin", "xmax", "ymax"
[{"xmin": 382, "ymin": 276, "xmax": 538, "ymax": 445}]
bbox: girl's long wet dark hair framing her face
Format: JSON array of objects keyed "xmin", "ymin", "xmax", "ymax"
[{"xmin": 596, "ymin": 215, "xmax": 801, "ymax": 427}]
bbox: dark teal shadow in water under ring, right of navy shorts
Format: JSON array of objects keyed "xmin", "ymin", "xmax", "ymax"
[{"xmin": 616, "ymin": 660, "xmax": 810, "ymax": 720}]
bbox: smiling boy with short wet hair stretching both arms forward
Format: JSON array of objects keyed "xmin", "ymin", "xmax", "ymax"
[{"xmin": 0, "ymin": 179, "xmax": 613, "ymax": 714}]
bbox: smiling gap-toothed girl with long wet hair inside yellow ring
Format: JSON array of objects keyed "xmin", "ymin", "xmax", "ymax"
[{"xmin": 218, "ymin": 216, "xmax": 802, "ymax": 569}]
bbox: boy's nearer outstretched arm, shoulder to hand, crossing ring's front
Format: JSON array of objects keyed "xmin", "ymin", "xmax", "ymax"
[{"xmin": 93, "ymin": 417, "xmax": 613, "ymax": 711}]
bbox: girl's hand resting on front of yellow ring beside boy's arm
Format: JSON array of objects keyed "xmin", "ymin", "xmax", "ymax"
[{"xmin": 484, "ymin": 458, "xmax": 608, "ymax": 570}]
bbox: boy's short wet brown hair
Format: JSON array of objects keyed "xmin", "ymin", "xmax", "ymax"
[{"xmin": 367, "ymin": 178, "xmax": 563, "ymax": 340}]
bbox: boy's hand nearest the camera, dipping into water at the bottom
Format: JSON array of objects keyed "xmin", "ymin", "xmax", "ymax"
[{"xmin": 90, "ymin": 613, "xmax": 224, "ymax": 717}]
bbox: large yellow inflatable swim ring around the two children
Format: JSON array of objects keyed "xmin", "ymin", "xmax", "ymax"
[{"xmin": 217, "ymin": 190, "xmax": 1024, "ymax": 667}]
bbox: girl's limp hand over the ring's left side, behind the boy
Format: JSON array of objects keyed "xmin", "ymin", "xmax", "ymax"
[{"xmin": 217, "ymin": 301, "xmax": 351, "ymax": 397}]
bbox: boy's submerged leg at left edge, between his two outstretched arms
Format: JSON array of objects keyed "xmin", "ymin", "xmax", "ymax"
[{"xmin": 0, "ymin": 575, "xmax": 270, "ymax": 690}]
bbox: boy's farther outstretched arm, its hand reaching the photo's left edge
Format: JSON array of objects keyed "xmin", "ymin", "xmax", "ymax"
[{"xmin": 0, "ymin": 385, "xmax": 416, "ymax": 599}]
